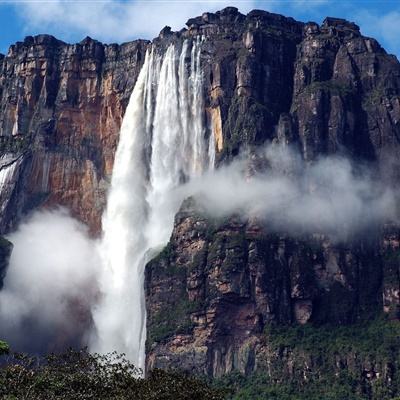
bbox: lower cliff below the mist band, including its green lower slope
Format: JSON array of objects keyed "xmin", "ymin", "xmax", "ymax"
[{"xmin": 146, "ymin": 199, "xmax": 400, "ymax": 399}]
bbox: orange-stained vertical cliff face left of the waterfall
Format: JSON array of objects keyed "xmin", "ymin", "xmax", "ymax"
[{"xmin": 0, "ymin": 35, "xmax": 147, "ymax": 233}]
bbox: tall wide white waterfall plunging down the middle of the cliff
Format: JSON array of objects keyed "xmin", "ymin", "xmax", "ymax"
[{"xmin": 92, "ymin": 38, "xmax": 215, "ymax": 368}]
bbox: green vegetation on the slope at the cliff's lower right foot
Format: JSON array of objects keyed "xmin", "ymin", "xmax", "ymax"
[{"xmin": 216, "ymin": 317, "xmax": 400, "ymax": 400}]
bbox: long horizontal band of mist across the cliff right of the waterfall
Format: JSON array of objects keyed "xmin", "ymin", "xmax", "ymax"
[{"xmin": 180, "ymin": 144, "xmax": 399, "ymax": 240}]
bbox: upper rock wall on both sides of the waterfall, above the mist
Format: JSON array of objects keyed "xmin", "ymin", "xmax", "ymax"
[{"xmin": 0, "ymin": 7, "xmax": 400, "ymax": 234}]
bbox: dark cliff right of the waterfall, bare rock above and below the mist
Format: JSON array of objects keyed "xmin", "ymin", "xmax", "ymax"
[{"xmin": 141, "ymin": 9, "xmax": 400, "ymax": 390}]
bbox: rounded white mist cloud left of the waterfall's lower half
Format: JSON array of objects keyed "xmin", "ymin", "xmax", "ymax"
[{"xmin": 0, "ymin": 209, "xmax": 97, "ymax": 353}]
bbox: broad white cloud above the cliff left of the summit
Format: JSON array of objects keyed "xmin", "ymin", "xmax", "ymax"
[{"xmin": 10, "ymin": 0, "xmax": 256, "ymax": 42}]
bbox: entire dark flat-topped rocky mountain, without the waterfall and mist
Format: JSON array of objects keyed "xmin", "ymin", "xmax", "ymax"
[{"xmin": 0, "ymin": 7, "xmax": 400, "ymax": 399}]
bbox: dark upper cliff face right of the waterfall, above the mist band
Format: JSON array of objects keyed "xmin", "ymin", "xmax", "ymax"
[{"xmin": 183, "ymin": 8, "xmax": 400, "ymax": 166}]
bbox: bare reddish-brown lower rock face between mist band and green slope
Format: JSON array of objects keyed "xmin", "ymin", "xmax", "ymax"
[{"xmin": 146, "ymin": 200, "xmax": 400, "ymax": 382}]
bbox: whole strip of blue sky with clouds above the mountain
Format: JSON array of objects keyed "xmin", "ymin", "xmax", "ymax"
[{"xmin": 0, "ymin": 0, "xmax": 400, "ymax": 57}]
